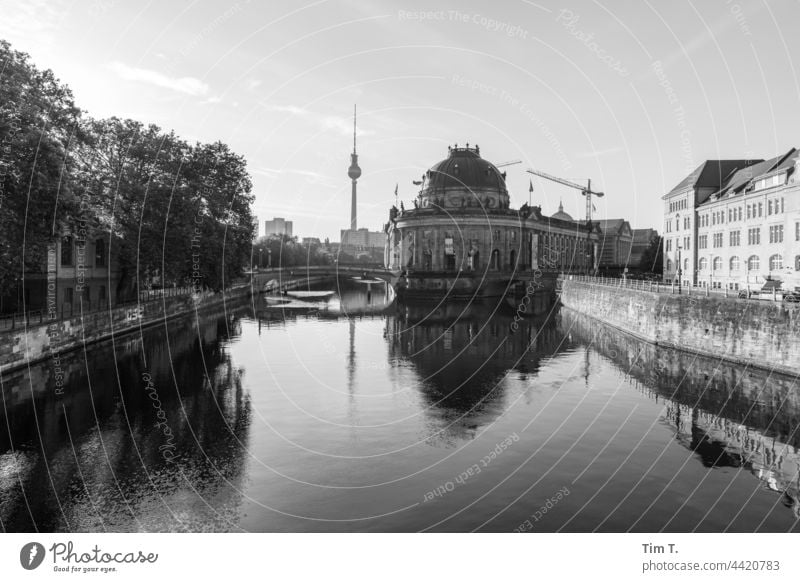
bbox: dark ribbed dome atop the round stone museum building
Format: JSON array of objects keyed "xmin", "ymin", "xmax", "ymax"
[{"xmin": 420, "ymin": 146, "xmax": 508, "ymax": 208}]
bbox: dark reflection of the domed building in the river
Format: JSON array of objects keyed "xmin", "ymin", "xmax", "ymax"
[{"xmin": 385, "ymin": 302, "xmax": 566, "ymax": 437}]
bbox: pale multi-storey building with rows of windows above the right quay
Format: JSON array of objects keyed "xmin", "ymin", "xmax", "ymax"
[{"xmin": 664, "ymin": 148, "xmax": 800, "ymax": 289}]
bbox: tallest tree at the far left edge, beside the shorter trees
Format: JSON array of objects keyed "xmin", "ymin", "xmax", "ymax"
[{"xmin": 0, "ymin": 40, "xmax": 84, "ymax": 295}]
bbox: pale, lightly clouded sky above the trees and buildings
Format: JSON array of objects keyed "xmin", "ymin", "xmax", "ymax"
[{"xmin": 0, "ymin": 0, "xmax": 800, "ymax": 240}]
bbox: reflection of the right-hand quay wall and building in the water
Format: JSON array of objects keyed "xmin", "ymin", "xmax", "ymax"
[{"xmin": 560, "ymin": 309, "xmax": 800, "ymax": 518}]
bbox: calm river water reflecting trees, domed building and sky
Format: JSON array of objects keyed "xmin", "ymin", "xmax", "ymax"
[{"xmin": 0, "ymin": 282, "xmax": 800, "ymax": 532}]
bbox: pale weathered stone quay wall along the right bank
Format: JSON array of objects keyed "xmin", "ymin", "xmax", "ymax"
[{"xmin": 561, "ymin": 278, "xmax": 800, "ymax": 375}]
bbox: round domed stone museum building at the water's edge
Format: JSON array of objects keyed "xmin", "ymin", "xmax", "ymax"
[{"xmin": 385, "ymin": 144, "xmax": 597, "ymax": 297}]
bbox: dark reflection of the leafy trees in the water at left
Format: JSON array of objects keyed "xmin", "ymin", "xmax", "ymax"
[{"xmin": 0, "ymin": 312, "xmax": 250, "ymax": 531}]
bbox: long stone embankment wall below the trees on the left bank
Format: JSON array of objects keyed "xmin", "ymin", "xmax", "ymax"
[{"xmin": 0, "ymin": 285, "xmax": 251, "ymax": 373}]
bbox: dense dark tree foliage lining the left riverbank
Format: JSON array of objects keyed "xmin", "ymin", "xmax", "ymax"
[{"xmin": 0, "ymin": 41, "xmax": 255, "ymax": 296}]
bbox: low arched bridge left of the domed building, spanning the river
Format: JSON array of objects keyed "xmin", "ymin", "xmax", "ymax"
[{"xmin": 251, "ymin": 265, "xmax": 400, "ymax": 292}]
